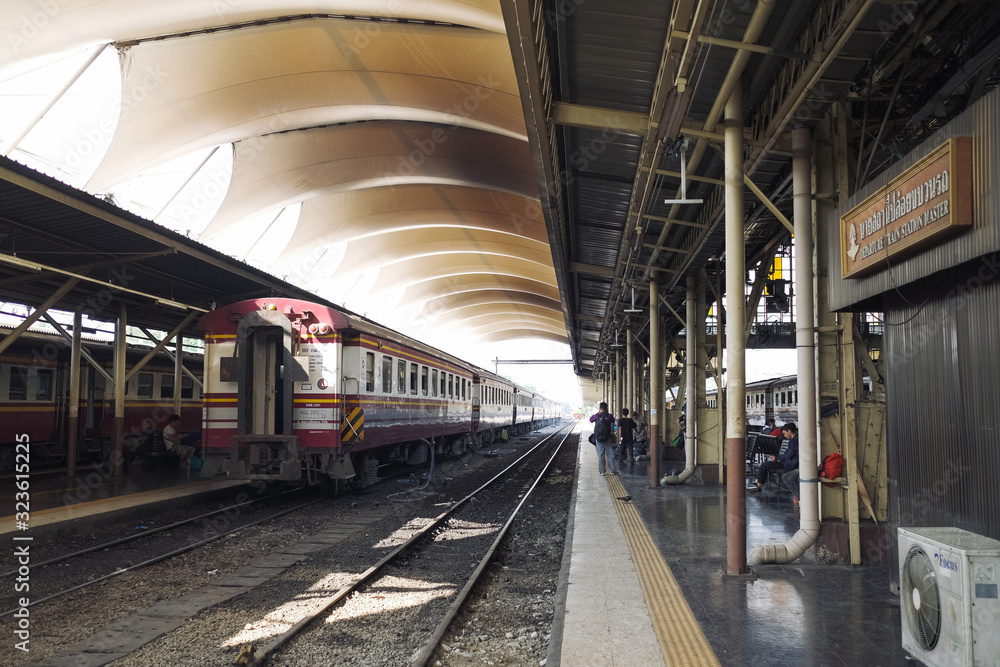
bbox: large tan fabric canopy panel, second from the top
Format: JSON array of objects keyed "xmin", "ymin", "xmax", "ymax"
[{"xmin": 87, "ymin": 18, "xmax": 525, "ymax": 192}]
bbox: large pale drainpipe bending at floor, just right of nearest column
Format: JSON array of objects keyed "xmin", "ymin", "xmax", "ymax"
[{"xmin": 750, "ymin": 128, "xmax": 819, "ymax": 565}]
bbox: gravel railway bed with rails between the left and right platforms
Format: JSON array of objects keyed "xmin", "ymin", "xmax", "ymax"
[{"xmin": 0, "ymin": 422, "xmax": 576, "ymax": 667}]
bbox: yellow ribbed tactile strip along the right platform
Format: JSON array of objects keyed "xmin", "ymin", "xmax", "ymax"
[{"xmin": 605, "ymin": 475, "xmax": 719, "ymax": 667}]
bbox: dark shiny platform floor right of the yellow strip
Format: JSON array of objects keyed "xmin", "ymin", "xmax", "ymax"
[{"xmin": 604, "ymin": 460, "xmax": 914, "ymax": 666}]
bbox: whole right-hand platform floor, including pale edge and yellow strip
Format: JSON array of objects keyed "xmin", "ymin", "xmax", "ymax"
[{"xmin": 546, "ymin": 434, "xmax": 913, "ymax": 667}]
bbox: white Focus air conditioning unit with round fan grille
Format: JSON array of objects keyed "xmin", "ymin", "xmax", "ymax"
[{"xmin": 898, "ymin": 528, "xmax": 1000, "ymax": 667}]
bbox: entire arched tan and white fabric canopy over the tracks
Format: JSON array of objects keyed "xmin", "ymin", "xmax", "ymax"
[{"xmin": 0, "ymin": 0, "xmax": 568, "ymax": 354}]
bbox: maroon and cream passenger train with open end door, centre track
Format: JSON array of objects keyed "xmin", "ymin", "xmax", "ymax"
[{"xmin": 199, "ymin": 298, "xmax": 564, "ymax": 486}]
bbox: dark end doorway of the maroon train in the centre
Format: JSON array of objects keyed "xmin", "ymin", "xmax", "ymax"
[{"xmin": 237, "ymin": 310, "xmax": 309, "ymax": 435}]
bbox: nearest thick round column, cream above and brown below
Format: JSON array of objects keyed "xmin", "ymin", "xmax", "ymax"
[{"xmin": 725, "ymin": 85, "xmax": 748, "ymax": 575}]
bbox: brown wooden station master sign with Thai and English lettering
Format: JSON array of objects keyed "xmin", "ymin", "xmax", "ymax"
[{"xmin": 840, "ymin": 137, "xmax": 972, "ymax": 278}]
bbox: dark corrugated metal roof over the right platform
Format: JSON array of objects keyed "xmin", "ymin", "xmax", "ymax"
[{"xmin": 542, "ymin": 0, "xmax": 1000, "ymax": 374}]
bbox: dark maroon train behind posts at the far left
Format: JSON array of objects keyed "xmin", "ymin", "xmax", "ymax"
[{"xmin": 0, "ymin": 332, "xmax": 203, "ymax": 471}]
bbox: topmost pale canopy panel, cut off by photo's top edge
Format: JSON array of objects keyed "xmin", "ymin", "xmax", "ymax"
[{"xmin": 0, "ymin": 0, "xmax": 504, "ymax": 68}]
